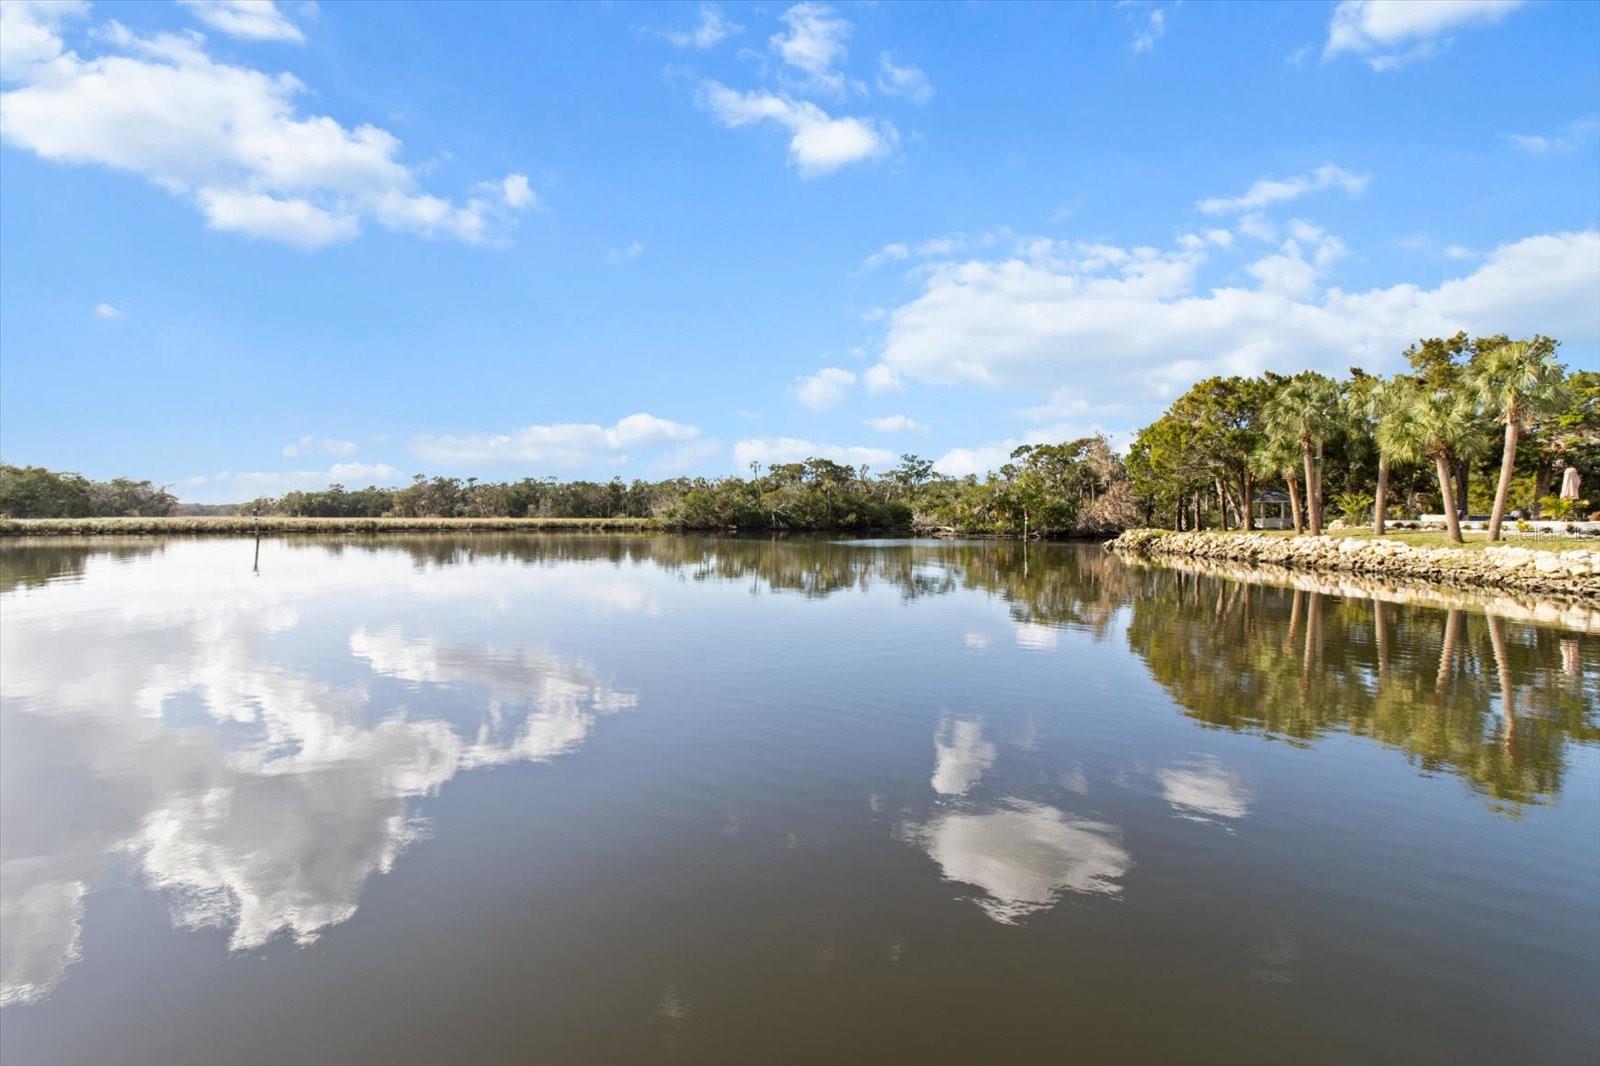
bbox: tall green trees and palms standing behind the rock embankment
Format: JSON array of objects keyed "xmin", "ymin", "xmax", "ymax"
[{"xmin": 1128, "ymin": 333, "xmax": 1600, "ymax": 543}]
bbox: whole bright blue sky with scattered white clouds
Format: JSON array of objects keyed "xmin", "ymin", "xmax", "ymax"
[{"xmin": 0, "ymin": 0, "xmax": 1600, "ymax": 501}]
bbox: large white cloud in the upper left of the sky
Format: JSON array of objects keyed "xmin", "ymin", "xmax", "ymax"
[{"xmin": 0, "ymin": 3, "xmax": 534, "ymax": 248}]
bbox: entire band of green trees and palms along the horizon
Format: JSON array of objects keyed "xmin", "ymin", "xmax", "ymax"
[{"xmin": 0, "ymin": 333, "xmax": 1600, "ymax": 538}]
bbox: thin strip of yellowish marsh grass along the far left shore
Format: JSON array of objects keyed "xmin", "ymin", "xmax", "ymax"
[{"xmin": 0, "ymin": 515, "xmax": 661, "ymax": 536}]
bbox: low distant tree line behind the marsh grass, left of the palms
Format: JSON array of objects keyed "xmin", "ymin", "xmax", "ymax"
[{"xmin": 0, "ymin": 437, "xmax": 1139, "ymax": 536}]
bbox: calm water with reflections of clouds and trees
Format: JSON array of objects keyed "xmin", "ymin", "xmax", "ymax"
[{"xmin": 0, "ymin": 535, "xmax": 1600, "ymax": 1063}]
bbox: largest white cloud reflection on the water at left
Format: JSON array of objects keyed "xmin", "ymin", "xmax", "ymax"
[{"xmin": 0, "ymin": 543, "xmax": 637, "ymax": 1004}]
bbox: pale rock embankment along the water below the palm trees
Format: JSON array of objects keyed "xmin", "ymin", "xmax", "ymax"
[{"xmin": 1107, "ymin": 530, "xmax": 1600, "ymax": 602}]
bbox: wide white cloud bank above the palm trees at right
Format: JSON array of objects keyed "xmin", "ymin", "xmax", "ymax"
[{"xmin": 869, "ymin": 222, "xmax": 1600, "ymax": 416}]
